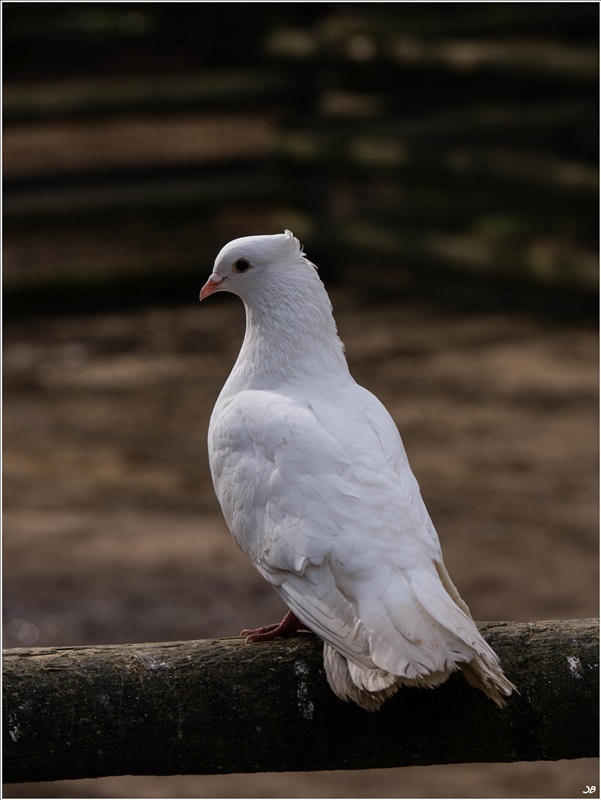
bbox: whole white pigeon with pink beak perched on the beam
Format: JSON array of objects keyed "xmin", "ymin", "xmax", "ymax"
[{"xmin": 200, "ymin": 231, "xmax": 515, "ymax": 711}]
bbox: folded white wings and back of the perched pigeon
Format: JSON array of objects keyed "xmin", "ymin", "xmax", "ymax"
[{"xmin": 209, "ymin": 382, "xmax": 500, "ymax": 679}]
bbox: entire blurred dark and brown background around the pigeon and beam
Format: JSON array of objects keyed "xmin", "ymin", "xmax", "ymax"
[{"xmin": 2, "ymin": 3, "xmax": 599, "ymax": 797}]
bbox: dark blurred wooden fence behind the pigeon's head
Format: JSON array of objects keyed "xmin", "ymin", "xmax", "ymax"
[{"xmin": 4, "ymin": 3, "xmax": 598, "ymax": 311}]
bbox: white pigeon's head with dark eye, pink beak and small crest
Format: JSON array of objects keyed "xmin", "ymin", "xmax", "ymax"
[{"xmin": 200, "ymin": 230, "xmax": 316, "ymax": 300}]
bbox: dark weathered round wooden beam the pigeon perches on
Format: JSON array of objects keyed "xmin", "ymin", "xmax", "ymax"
[{"xmin": 3, "ymin": 620, "xmax": 599, "ymax": 782}]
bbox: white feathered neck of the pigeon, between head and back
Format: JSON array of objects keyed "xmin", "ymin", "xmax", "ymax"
[{"xmin": 228, "ymin": 279, "xmax": 349, "ymax": 391}]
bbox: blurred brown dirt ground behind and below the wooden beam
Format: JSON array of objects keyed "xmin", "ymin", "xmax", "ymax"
[{"xmin": 4, "ymin": 290, "xmax": 599, "ymax": 798}]
